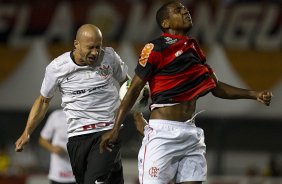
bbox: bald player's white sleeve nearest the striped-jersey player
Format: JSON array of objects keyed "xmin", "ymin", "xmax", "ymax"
[{"xmin": 113, "ymin": 50, "xmax": 128, "ymax": 82}]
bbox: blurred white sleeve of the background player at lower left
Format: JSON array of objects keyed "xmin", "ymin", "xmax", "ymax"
[{"xmin": 40, "ymin": 112, "xmax": 56, "ymax": 140}]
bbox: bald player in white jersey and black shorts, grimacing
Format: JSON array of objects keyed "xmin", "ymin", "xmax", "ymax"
[{"xmin": 15, "ymin": 24, "xmax": 128, "ymax": 184}]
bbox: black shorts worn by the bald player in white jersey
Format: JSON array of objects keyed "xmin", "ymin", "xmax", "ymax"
[{"xmin": 67, "ymin": 131, "xmax": 124, "ymax": 184}]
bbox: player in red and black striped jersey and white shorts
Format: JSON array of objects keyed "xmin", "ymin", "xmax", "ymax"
[{"xmin": 100, "ymin": 1, "xmax": 272, "ymax": 184}]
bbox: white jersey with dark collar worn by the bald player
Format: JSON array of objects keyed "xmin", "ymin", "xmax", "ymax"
[{"xmin": 41, "ymin": 47, "xmax": 128, "ymax": 137}]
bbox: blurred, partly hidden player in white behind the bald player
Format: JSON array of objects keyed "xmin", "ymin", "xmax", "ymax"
[{"xmin": 38, "ymin": 109, "xmax": 76, "ymax": 184}]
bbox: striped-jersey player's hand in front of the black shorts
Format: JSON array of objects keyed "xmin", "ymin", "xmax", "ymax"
[{"xmin": 100, "ymin": 129, "xmax": 118, "ymax": 153}]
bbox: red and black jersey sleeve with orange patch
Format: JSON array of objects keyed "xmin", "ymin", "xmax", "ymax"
[{"xmin": 135, "ymin": 43, "xmax": 156, "ymax": 81}]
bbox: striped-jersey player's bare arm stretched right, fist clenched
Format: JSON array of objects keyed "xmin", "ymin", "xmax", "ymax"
[{"xmin": 212, "ymin": 81, "xmax": 272, "ymax": 106}]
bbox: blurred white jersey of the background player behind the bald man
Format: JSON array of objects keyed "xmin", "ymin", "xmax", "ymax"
[{"xmin": 40, "ymin": 110, "xmax": 75, "ymax": 183}]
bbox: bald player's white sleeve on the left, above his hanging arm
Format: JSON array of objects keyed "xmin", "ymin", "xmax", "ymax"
[{"xmin": 40, "ymin": 63, "xmax": 58, "ymax": 98}]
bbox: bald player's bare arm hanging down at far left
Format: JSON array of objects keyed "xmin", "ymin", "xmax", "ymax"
[{"xmin": 15, "ymin": 95, "xmax": 51, "ymax": 152}]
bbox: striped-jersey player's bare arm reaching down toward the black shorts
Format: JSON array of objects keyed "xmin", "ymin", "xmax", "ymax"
[{"xmin": 100, "ymin": 75, "xmax": 146, "ymax": 153}]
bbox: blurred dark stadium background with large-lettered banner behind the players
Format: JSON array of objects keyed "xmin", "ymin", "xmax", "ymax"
[{"xmin": 0, "ymin": 0, "xmax": 282, "ymax": 184}]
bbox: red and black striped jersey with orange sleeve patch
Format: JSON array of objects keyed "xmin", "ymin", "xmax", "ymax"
[{"xmin": 135, "ymin": 33, "xmax": 216, "ymax": 104}]
